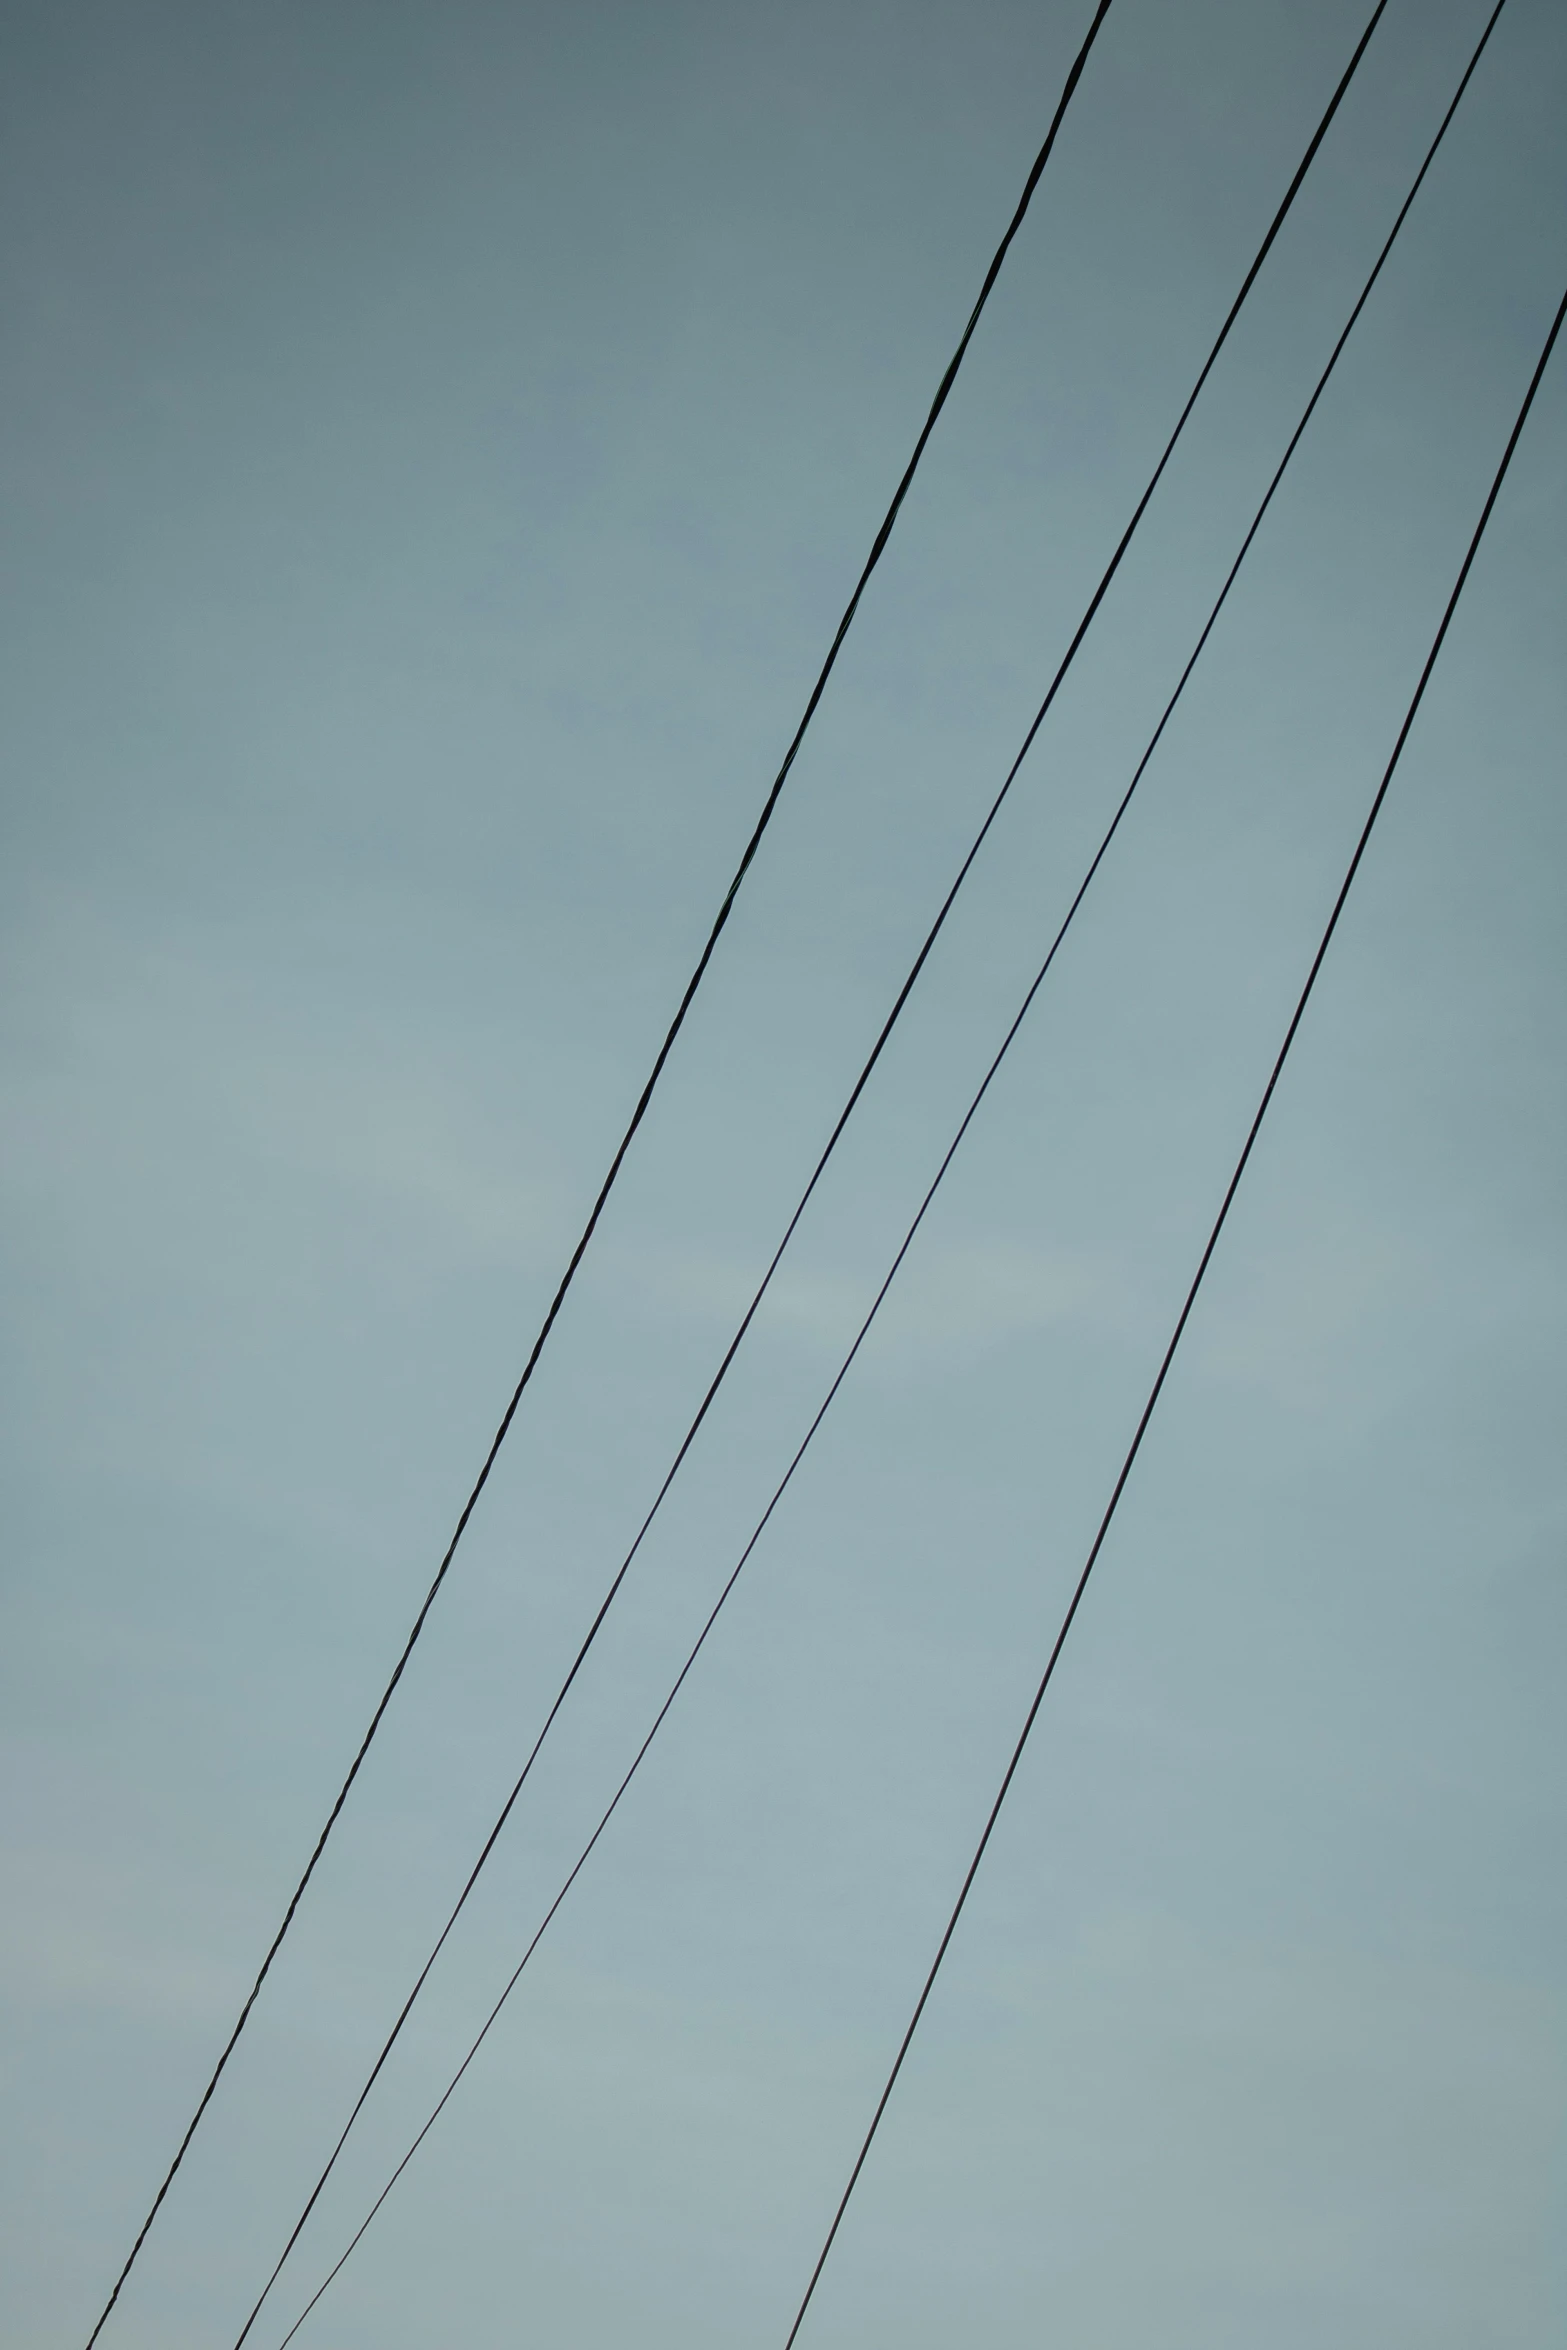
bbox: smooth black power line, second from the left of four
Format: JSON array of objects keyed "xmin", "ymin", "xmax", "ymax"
[{"xmin": 235, "ymin": 13, "xmax": 1386, "ymax": 2350}]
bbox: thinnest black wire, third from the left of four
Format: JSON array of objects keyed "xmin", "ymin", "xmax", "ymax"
[{"xmin": 266, "ymin": 13, "xmax": 1506, "ymax": 2350}]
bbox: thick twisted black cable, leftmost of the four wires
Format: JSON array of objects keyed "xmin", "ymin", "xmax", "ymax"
[{"xmin": 87, "ymin": 0, "xmax": 1111, "ymax": 2350}]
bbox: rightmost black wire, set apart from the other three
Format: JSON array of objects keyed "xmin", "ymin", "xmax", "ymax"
[{"xmin": 785, "ymin": 270, "xmax": 1567, "ymax": 2350}]
